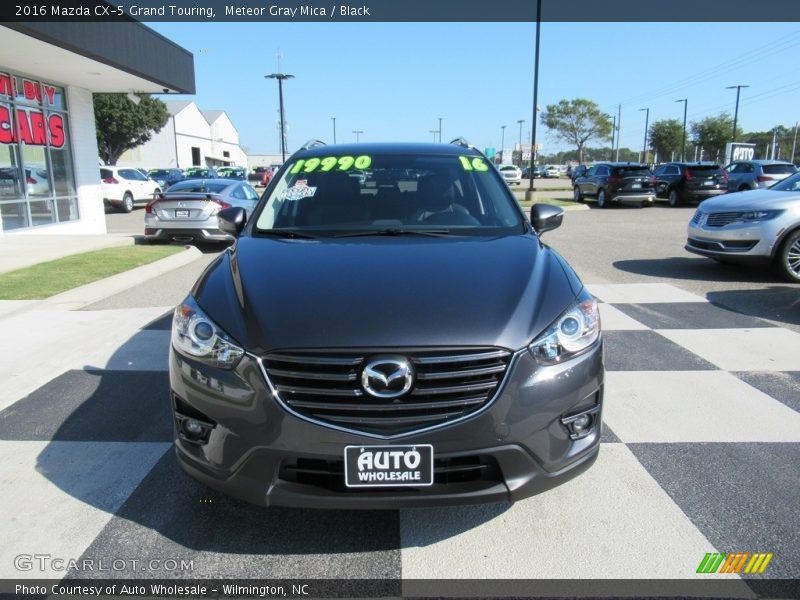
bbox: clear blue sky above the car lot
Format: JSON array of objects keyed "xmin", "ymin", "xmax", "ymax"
[{"xmin": 148, "ymin": 22, "xmax": 800, "ymax": 153}]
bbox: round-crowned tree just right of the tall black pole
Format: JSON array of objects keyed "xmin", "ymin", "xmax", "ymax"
[{"xmin": 541, "ymin": 98, "xmax": 611, "ymax": 162}]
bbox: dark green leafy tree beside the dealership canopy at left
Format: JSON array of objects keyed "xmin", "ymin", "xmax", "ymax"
[{"xmin": 94, "ymin": 94, "xmax": 169, "ymax": 165}]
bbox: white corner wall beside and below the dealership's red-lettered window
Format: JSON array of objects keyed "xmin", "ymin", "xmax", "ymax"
[{"xmin": 12, "ymin": 86, "xmax": 106, "ymax": 235}]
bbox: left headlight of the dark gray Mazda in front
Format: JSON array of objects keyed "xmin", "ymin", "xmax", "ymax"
[{"xmin": 172, "ymin": 296, "xmax": 244, "ymax": 369}]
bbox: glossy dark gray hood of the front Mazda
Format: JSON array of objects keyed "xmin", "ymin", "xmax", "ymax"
[{"xmin": 193, "ymin": 235, "xmax": 581, "ymax": 354}]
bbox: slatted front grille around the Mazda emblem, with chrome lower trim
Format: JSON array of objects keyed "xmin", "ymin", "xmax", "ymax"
[{"xmin": 263, "ymin": 348, "xmax": 511, "ymax": 436}]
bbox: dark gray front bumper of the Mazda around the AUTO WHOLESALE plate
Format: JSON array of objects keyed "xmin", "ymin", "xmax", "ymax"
[{"xmin": 169, "ymin": 342, "xmax": 604, "ymax": 509}]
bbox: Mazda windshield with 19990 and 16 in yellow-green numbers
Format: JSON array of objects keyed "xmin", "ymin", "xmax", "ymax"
[{"xmin": 256, "ymin": 154, "xmax": 524, "ymax": 236}]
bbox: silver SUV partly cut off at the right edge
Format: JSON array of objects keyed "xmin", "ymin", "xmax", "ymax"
[{"xmin": 686, "ymin": 168, "xmax": 800, "ymax": 283}]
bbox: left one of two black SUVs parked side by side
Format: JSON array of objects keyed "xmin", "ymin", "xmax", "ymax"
[{"xmin": 572, "ymin": 162, "xmax": 656, "ymax": 208}]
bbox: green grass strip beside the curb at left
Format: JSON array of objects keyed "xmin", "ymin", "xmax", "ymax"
[{"xmin": 0, "ymin": 246, "xmax": 183, "ymax": 300}]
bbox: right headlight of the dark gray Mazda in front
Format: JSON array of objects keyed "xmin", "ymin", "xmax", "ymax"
[{"xmin": 528, "ymin": 289, "xmax": 600, "ymax": 365}]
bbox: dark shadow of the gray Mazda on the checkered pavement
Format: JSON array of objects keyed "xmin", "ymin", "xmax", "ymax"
[{"xmin": 26, "ymin": 313, "xmax": 510, "ymax": 564}]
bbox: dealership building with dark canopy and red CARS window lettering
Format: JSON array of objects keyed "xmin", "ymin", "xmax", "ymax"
[{"xmin": 0, "ymin": 21, "xmax": 194, "ymax": 235}]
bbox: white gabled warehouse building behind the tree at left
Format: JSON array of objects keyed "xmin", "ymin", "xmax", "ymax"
[{"xmin": 117, "ymin": 101, "xmax": 247, "ymax": 169}]
